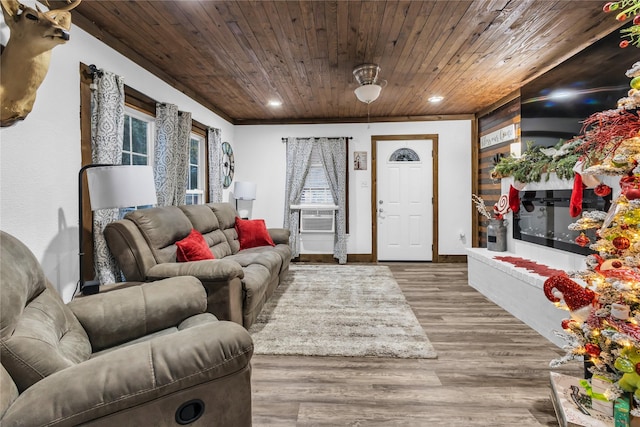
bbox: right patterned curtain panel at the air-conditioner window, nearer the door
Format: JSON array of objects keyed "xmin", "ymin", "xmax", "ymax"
[{"xmin": 318, "ymin": 138, "xmax": 348, "ymax": 264}]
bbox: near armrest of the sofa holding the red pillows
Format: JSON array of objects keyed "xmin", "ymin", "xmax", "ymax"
[{"xmin": 147, "ymin": 258, "xmax": 244, "ymax": 282}]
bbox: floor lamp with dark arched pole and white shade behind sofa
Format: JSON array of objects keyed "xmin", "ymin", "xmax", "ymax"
[{"xmin": 78, "ymin": 164, "xmax": 158, "ymax": 295}]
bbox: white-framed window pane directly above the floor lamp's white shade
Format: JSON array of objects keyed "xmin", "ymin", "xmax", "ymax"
[{"xmin": 122, "ymin": 107, "xmax": 154, "ymax": 165}]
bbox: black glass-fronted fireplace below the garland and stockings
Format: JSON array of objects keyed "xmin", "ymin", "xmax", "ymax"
[{"xmin": 513, "ymin": 189, "xmax": 611, "ymax": 255}]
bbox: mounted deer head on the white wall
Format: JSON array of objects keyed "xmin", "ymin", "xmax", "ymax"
[{"xmin": 0, "ymin": 0, "xmax": 81, "ymax": 127}]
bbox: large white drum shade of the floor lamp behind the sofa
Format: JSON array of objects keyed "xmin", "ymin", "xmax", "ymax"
[{"xmin": 87, "ymin": 165, "xmax": 158, "ymax": 211}]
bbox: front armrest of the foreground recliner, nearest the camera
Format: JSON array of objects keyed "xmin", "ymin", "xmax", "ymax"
[{"xmin": 2, "ymin": 322, "xmax": 253, "ymax": 426}]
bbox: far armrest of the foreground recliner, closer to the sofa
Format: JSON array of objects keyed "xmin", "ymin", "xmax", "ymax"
[{"xmin": 68, "ymin": 276, "xmax": 207, "ymax": 353}]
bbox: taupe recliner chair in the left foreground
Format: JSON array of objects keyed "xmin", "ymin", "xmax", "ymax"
[{"xmin": 0, "ymin": 232, "xmax": 253, "ymax": 427}]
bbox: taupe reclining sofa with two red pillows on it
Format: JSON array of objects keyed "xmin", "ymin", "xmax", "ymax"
[{"xmin": 104, "ymin": 203, "xmax": 291, "ymax": 328}]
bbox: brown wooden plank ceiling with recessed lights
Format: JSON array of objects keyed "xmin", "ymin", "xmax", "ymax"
[{"xmin": 62, "ymin": 0, "xmax": 633, "ymax": 124}]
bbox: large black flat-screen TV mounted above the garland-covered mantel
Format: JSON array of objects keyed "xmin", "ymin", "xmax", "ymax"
[{"xmin": 520, "ymin": 23, "xmax": 640, "ymax": 151}]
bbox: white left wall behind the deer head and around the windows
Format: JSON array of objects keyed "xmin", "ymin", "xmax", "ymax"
[{"xmin": 0, "ymin": 10, "xmax": 234, "ymax": 300}]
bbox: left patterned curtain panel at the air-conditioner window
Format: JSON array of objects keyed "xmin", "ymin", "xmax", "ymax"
[{"xmin": 284, "ymin": 138, "xmax": 315, "ymax": 258}]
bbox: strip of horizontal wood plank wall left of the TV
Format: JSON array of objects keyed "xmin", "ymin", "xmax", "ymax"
[{"xmin": 474, "ymin": 97, "xmax": 520, "ymax": 248}]
